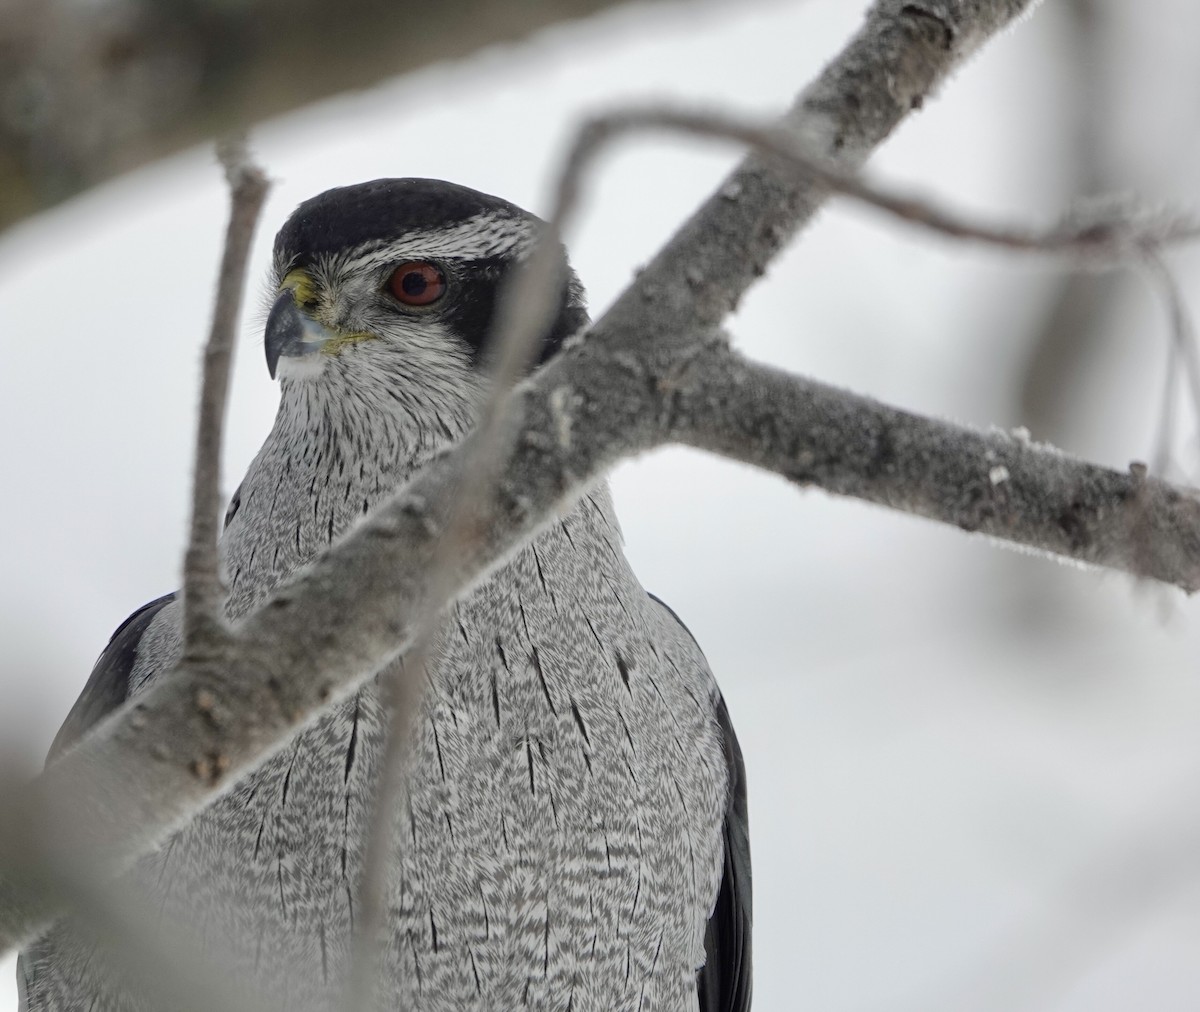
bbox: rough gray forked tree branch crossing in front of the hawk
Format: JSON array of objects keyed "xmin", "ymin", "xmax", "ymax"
[{"xmin": 9, "ymin": 0, "xmax": 1200, "ymax": 945}]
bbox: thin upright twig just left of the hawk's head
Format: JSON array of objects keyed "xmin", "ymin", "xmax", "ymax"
[{"xmin": 184, "ymin": 138, "xmax": 270, "ymax": 655}]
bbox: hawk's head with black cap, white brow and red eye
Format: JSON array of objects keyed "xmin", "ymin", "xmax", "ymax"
[{"xmin": 265, "ymin": 179, "xmax": 587, "ymax": 393}]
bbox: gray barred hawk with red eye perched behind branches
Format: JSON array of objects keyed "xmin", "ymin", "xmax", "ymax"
[{"xmin": 18, "ymin": 179, "xmax": 751, "ymax": 1012}]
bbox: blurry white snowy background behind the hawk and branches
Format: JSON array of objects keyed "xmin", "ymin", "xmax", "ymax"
[{"xmin": 0, "ymin": 0, "xmax": 1200, "ymax": 1012}]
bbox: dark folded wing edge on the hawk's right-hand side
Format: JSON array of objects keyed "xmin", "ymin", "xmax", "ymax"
[{"xmin": 650, "ymin": 594, "xmax": 754, "ymax": 1012}]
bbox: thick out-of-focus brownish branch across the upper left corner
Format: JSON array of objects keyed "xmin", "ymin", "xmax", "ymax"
[{"xmin": 0, "ymin": 0, "xmax": 667, "ymax": 230}]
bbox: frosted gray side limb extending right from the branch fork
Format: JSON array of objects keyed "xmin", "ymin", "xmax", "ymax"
[{"xmin": 672, "ymin": 346, "xmax": 1200, "ymax": 591}]
